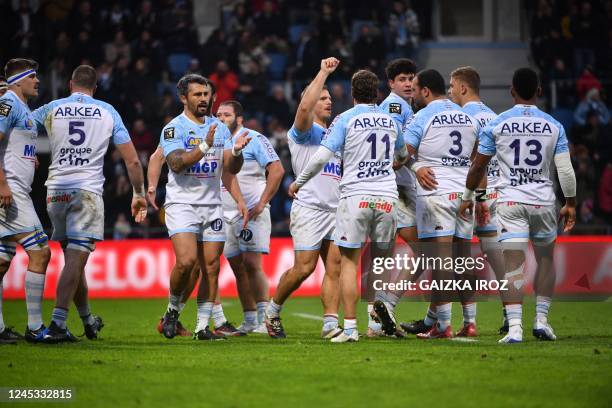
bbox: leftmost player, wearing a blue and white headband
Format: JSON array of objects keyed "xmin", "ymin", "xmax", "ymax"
[{"xmin": 0, "ymin": 58, "xmax": 51, "ymax": 343}]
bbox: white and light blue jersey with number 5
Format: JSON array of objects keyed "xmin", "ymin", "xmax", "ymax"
[{"xmin": 34, "ymin": 92, "xmax": 130, "ymax": 194}]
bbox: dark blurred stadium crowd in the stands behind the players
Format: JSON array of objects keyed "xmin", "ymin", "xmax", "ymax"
[{"xmin": 0, "ymin": 0, "xmax": 612, "ymax": 238}]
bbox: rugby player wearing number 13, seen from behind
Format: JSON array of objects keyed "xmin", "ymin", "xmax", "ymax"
[{"xmin": 460, "ymin": 68, "xmax": 576, "ymax": 343}]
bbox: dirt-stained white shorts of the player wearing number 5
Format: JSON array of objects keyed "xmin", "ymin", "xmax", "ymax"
[{"xmin": 47, "ymin": 189, "xmax": 104, "ymax": 242}]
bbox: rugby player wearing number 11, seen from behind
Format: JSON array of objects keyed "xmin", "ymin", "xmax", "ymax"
[{"xmin": 289, "ymin": 70, "xmax": 408, "ymax": 343}]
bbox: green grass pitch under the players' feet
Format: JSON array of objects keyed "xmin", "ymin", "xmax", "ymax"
[{"xmin": 0, "ymin": 299, "xmax": 612, "ymax": 408}]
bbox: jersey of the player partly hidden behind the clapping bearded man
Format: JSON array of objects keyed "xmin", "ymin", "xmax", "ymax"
[{"xmin": 221, "ymin": 128, "xmax": 280, "ymax": 221}]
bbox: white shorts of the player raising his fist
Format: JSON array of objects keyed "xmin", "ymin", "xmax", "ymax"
[{"xmin": 289, "ymin": 201, "xmax": 336, "ymax": 251}]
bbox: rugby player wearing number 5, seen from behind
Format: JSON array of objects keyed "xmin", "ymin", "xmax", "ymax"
[{"xmin": 34, "ymin": 65, "xmax": 147, "ymax": 343}]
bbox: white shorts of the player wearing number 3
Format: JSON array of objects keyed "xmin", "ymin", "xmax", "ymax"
[{"xmin": 416, "ymin": 193, "xmax": 474, "ymax": 239}]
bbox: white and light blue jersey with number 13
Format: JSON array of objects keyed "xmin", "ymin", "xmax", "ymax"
[{"xmin": 478, "ymin": 105, "xmax": 569, "ymax": 205}]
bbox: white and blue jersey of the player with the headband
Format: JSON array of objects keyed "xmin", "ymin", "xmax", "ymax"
[{"xmin": 0, "ymin": 91, "xmax": 38, "ymax": 194}]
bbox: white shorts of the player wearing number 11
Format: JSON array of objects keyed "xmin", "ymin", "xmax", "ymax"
[{"xmin": 334, "ymin": 195, "xmax": 397, "ymax": 248}]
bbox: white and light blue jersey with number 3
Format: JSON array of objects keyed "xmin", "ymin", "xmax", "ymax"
[{"xmin": 404, "ymin": 99, "xmax": 480, "ymax": 196}]
